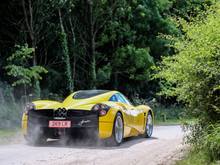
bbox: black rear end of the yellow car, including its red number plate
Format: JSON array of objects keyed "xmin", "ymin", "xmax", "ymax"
[{"xmin": 22, "ymin": 108, "xmax": 99, "ymax": 142}]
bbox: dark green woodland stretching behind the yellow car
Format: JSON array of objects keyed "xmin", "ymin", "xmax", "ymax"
[{"xmin": 0, "ymin": 0, "xmax": 211, "ymax": 97}]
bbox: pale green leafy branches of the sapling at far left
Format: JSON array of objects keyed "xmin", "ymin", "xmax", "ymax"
[{"xmin": 5, "ymin": 44, "xmax": 47, "ymax": 86}]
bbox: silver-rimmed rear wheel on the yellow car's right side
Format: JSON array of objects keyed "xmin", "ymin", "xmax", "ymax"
[{"xmin": 108, "ymin": 113, "xmax": 124, "ymax": 146}]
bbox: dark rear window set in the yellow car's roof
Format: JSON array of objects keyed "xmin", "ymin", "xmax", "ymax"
[{"xmin": 73, "ymin": 90, "xmax": 109, "ymax": 99}]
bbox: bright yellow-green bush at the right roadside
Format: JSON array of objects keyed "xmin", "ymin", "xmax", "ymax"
[{"xmin": 155, "ymin": 2, "xmax": 220, "ymax": 164}]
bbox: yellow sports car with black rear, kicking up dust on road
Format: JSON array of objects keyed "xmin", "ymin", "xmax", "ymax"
[{"xmin": 22, "ymin": 90, "xmax": 154, "ymax": 145}]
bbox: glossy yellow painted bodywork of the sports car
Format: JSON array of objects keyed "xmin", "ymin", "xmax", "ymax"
[{"xmin": 22, "ymin": 91, "xmax": 153, "ymax": 139}]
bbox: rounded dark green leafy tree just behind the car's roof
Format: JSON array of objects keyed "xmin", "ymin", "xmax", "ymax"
[{"xmin": 112, "ymin": 45, "xmax": 154, "ymax": 95}]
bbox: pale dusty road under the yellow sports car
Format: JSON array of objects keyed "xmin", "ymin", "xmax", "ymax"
[{"xmin": 0, "ymin": 126, "xmax": 183, "ymax": 165}]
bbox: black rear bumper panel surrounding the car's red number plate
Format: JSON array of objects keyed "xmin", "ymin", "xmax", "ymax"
[{"xmin": 26, "ymin": 110, "xmax": 99, "ymax": 138}]
